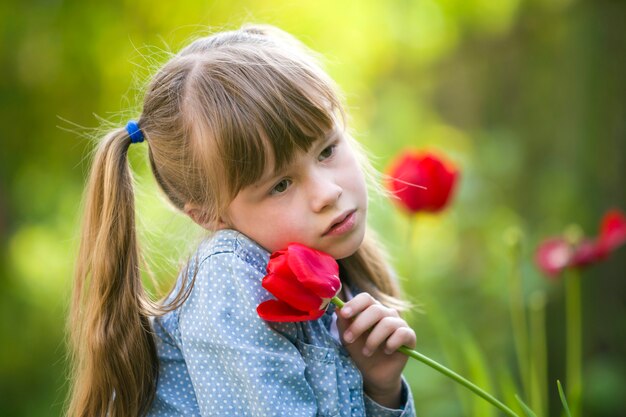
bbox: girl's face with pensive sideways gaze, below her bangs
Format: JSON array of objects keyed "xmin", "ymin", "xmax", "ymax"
[{"xmin": 222, "ymin": 130, "xmax": 367, "ymax": 259}]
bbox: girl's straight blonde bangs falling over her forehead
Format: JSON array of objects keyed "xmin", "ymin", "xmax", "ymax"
[{"xmin": 180, "ymin": 45, "xmax": 344, "ymax": 211}]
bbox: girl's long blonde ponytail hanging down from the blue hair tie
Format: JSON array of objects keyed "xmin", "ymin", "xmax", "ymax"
[{"xmin": 68, "ymin": 129, "xmax": 158, "ymax": 417}]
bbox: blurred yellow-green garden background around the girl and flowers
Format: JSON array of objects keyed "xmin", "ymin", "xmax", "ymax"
[{"xmin": 0, "ymin": 0, "xmax": 626, "ymax": 417}]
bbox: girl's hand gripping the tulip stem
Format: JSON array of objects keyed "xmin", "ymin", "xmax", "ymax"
[{"xmin": 337, "ymin": 293, "xmax": 415, "ymax": 408}]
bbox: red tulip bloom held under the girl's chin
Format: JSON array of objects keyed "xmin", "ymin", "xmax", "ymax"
[{"xmin": 257, "ymin": 243, "xmax": 341, "ymax": 322}]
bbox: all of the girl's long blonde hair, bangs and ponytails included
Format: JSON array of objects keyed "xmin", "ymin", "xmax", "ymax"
[{"xmin": 68, "ymin": 26, "xmax": 402, "ymax": 417}]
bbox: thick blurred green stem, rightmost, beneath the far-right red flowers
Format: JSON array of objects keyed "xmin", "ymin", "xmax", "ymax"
[{"xmin": 565, "ymin": 268, "xmax": 582, "ymax": 417}]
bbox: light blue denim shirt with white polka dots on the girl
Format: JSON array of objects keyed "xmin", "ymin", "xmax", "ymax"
[{"xmin": 148, "ymin": 230, "xmax": 415, "ymax": 417}]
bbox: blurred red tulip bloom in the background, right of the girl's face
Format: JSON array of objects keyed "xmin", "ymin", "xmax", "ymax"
[{"xmin": 387, "ymin": 152, "xmax": 459, "ymax": 213}]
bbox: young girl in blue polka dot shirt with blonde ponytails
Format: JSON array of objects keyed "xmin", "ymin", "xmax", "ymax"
[{"xmin": 69, "ymin": 26, "xmax": 415, "ymax": 417}]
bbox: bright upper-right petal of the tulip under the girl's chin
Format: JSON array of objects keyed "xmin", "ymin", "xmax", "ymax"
[{"xmin": 287, "ymin": 243, "xmax": 341, "ymax": 298}]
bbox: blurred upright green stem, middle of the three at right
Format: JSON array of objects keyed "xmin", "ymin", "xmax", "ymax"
[{"xmin": 530, "ymin": 290, "xmax": 548, "ymax": 416}]
